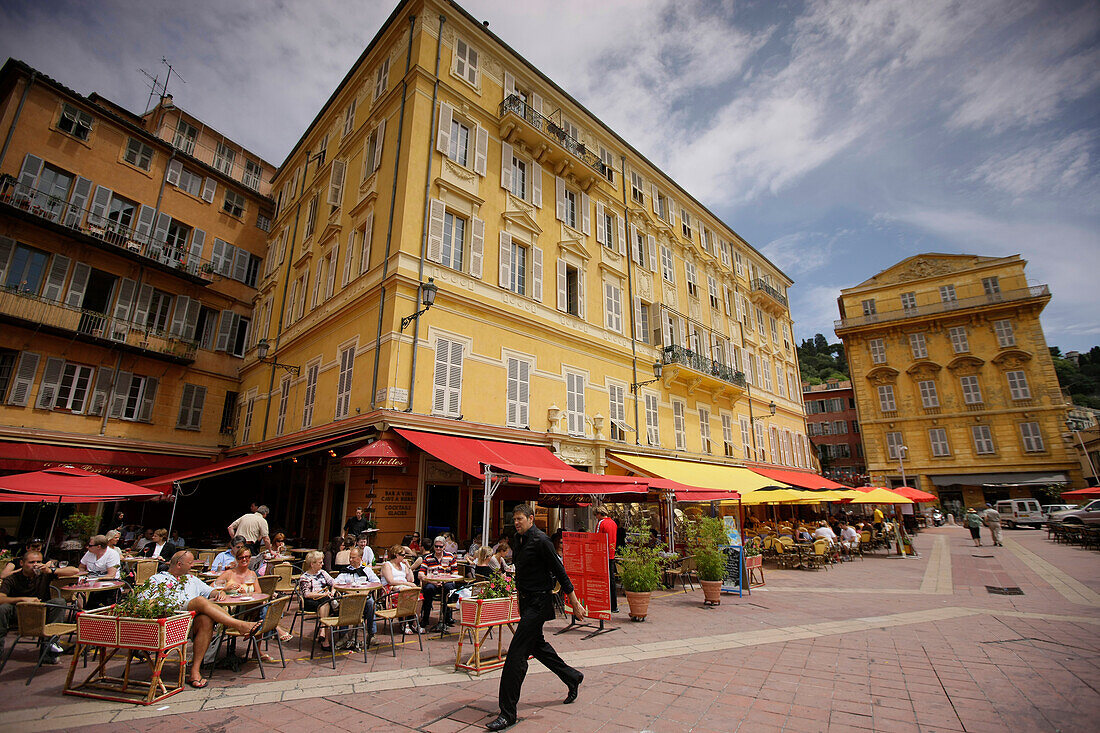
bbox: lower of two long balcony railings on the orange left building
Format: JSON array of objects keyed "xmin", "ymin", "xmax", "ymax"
[{"xmin": 0, "ymin": 287, "xmax": 197, "ymax": 362}]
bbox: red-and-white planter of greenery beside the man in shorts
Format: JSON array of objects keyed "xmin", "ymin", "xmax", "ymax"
[{"xmin": 65, "ymin": 581, "xmax": 195, "ymax": 705}]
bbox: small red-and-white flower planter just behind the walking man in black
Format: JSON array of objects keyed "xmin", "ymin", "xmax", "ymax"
[{"xmin": 454, "ymin": 572, "xmax": 519, "ymax": 675}]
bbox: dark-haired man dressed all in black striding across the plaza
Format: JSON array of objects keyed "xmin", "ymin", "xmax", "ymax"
[{"xmin": 486, "ymin": 504, "xmax": 585, "ymax": 731}]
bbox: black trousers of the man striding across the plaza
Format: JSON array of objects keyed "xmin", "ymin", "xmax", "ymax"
[{"xmin": 499, "ymin": 591, "xmax": 581, "ymax": 720}]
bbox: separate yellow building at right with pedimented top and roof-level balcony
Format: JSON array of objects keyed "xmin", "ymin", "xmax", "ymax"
[{"xmin": 836, "ymin": 254, "xmax": 1081, "ymax": 513}]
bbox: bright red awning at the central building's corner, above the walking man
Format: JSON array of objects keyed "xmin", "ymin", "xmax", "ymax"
[{"xmin": 396, "ymin": 428, "xmax": 649, "ymax": 494}]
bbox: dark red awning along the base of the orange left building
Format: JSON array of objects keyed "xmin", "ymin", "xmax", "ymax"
[{"xmin": 0, "ymin": 442, "xmax": 207, "ymax": 477}]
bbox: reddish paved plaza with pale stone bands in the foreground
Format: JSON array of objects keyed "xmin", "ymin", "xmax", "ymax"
[{"xmin": 0, "ymin": 527, "xmax": 1100, "ymax": 733}]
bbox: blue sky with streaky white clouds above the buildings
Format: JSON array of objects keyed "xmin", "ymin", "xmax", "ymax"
[{"xmin": 0, "ymin": 0, "xmax": 1100, "ymax": 351}]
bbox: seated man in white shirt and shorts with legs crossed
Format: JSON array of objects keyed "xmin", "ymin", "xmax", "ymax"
[{"xmin": 150, "ymin": 550, "xmax": 264, "ymax": 688}]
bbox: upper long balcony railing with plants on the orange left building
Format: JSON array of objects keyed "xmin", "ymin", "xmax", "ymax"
[{"xmin": 0, "ymin": 176, "xmax": 213, "ymax": 283}]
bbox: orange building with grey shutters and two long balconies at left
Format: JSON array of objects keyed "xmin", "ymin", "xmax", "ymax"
[{"xmin": 0, "ymin": 61, "xmax": 275, "ymax": 528}]
